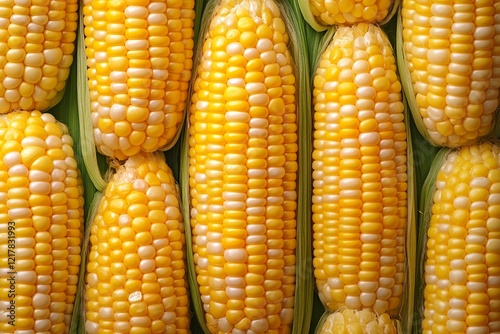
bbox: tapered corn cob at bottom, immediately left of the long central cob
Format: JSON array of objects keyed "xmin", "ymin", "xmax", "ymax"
[{"xmin": 85, "ymin": 153, "xmax": 189, "ymax": 334}]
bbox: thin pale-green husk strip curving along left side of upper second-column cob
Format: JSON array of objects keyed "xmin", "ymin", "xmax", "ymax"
[{"xmin": 76, "ymin": 0, "xmax": 107, "ymax": 191}]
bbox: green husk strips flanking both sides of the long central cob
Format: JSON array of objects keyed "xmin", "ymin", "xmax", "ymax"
[{"xmin": 180, "ymin": 0, "xmax": 313, "ymax": 334}]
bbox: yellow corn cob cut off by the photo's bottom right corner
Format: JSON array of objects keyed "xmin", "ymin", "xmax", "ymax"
[{"xmin": 422, "ymin": 142, "xmax": 500, "ymax": 334}]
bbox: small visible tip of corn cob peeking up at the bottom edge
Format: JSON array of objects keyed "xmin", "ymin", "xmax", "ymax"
[{"xmin": 319, "ymin": 308, "xmax": 397, "ymax": 334}]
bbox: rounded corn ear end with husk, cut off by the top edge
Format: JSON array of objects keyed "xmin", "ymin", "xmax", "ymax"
[{"xmin": 298, "ymin": 0, "xmax": 399, "ymax": 31}]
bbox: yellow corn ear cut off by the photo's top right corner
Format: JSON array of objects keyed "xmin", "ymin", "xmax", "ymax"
[{"xmin": 398, "ymin": 0, "xmax": 500, "ymax": 147}]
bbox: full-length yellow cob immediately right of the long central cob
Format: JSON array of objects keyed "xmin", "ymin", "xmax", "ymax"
[{"xmin": 312, "ymin": 23, "xmax": 407, "ymax": 314}]
